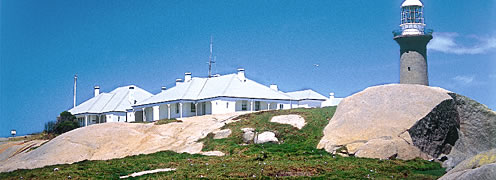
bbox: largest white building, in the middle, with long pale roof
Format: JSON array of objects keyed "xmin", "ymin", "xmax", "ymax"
[{"xmin": 128, "ymin": 69, "xmax": 298, "ymax": 121}]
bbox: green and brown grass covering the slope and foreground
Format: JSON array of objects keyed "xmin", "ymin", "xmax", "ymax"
[{"xmin": 0, "ymin": 107, "xmax": 444, "ymax": 179}]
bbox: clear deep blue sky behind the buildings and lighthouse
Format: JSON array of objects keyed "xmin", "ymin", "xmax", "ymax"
[{"xmin": 0, "ymin": 0, "xmax": 496, "ymax": 136}]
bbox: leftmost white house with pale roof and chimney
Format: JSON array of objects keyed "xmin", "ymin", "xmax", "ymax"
[{"xmin": 69, "ymin": 85, "xmax": 153, "ymax": 126}]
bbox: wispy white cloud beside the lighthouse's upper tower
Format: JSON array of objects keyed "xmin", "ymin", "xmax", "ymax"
[{"xmin": 427, "ymin": 33, "xmax": 496, "ymax": 54}]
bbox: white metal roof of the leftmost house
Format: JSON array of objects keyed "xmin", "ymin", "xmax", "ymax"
[{"xmin": 69, "ymin": 85, "xmax": 153, "ymax": 115}]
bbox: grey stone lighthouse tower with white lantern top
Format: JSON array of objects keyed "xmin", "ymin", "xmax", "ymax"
[{"xmin": 393, "ymin": 0, "xmax": 432, "ymax": 86}]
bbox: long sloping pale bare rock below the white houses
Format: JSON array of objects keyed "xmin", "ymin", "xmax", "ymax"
[{"xmin": 0, "ymin": 113, "xmax": 246, "ymax": 172}]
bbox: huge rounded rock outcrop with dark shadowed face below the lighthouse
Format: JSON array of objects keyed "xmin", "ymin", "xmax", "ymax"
[{"xmin": 318, "ymin": 84, "xmax": 496, "ymax": 167}]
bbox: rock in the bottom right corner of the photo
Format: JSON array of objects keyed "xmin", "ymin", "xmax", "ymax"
[{"xmin": 440, "ymin": 149, "xmax": 496, "ymax": 180}]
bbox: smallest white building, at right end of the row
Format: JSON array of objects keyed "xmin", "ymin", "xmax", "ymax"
[{"xmin": 286, "ymin": 89, "xmax": 328, "ymax": 108}]
